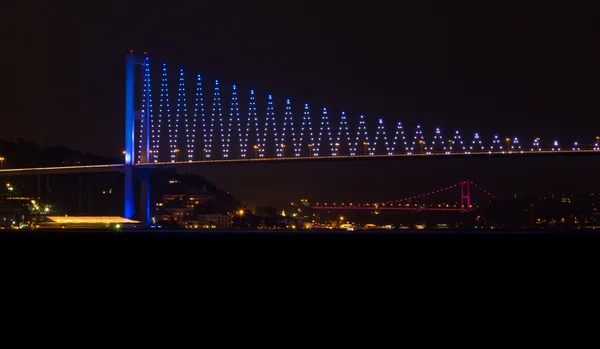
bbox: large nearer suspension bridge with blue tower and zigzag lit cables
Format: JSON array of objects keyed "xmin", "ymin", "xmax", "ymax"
[{"xmin": 0, "ymin": 51, "xmax": 600, "ymax": 222}]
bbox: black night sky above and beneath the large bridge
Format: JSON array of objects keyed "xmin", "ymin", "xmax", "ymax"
[{"xmin": 0, "ymin": 1, "xmax": 600, "ymax": 204}]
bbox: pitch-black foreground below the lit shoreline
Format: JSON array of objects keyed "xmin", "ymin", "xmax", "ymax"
[{"xmin": 0, "ymin": 231, "xmax": 600, "ymax": 348}]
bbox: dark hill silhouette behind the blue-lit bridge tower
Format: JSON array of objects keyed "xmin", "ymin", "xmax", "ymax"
[{"xmin": 0, "ymin": 139, "xmax": 240, "ymax": 215}]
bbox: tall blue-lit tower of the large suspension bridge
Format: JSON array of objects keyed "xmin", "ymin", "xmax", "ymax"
[{"xmin": 123, "ymin": 51, "xmax": 151, "ymax": 224}]
